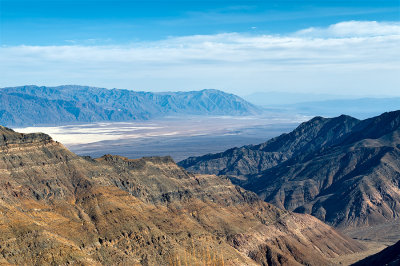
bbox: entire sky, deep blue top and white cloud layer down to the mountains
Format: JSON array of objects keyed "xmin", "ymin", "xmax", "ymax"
[{"xmin": 0, "ymin": 0, "xmax": 400, "ymax": 97}]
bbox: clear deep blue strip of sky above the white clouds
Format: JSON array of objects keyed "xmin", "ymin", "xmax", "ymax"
[{"xmin": 0, "ymin": 0, "xmax": 400, "ymax": 45}]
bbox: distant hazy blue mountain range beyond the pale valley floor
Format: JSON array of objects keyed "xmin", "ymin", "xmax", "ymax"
[{"xmin": 0, "ymin": 85, "xmax": 260, "ymax": 126}]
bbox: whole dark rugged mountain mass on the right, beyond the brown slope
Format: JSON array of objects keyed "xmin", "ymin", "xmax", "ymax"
[{"xmin": 179, "ymin": 111, "xmax": 400, "ymax": 230}]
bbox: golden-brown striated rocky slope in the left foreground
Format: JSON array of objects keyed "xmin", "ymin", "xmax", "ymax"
[{"xmin": 0, "ymin": 128, "xmax": 363, "ymax": 265}]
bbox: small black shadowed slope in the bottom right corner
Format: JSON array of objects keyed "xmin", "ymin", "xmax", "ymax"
[{"xmin": 352, "ymin": 241, "xmax": 400, "ymax": 266}]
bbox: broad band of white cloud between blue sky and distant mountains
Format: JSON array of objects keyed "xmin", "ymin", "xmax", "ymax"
[{"xmin": 0, "ymin": 21, "xmax": 400, "ymax": 95}]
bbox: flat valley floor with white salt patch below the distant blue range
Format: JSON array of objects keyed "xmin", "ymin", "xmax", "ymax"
[{"xmin": 15, "ymin": 115, "xmax": 309, "ymax": 161}]
